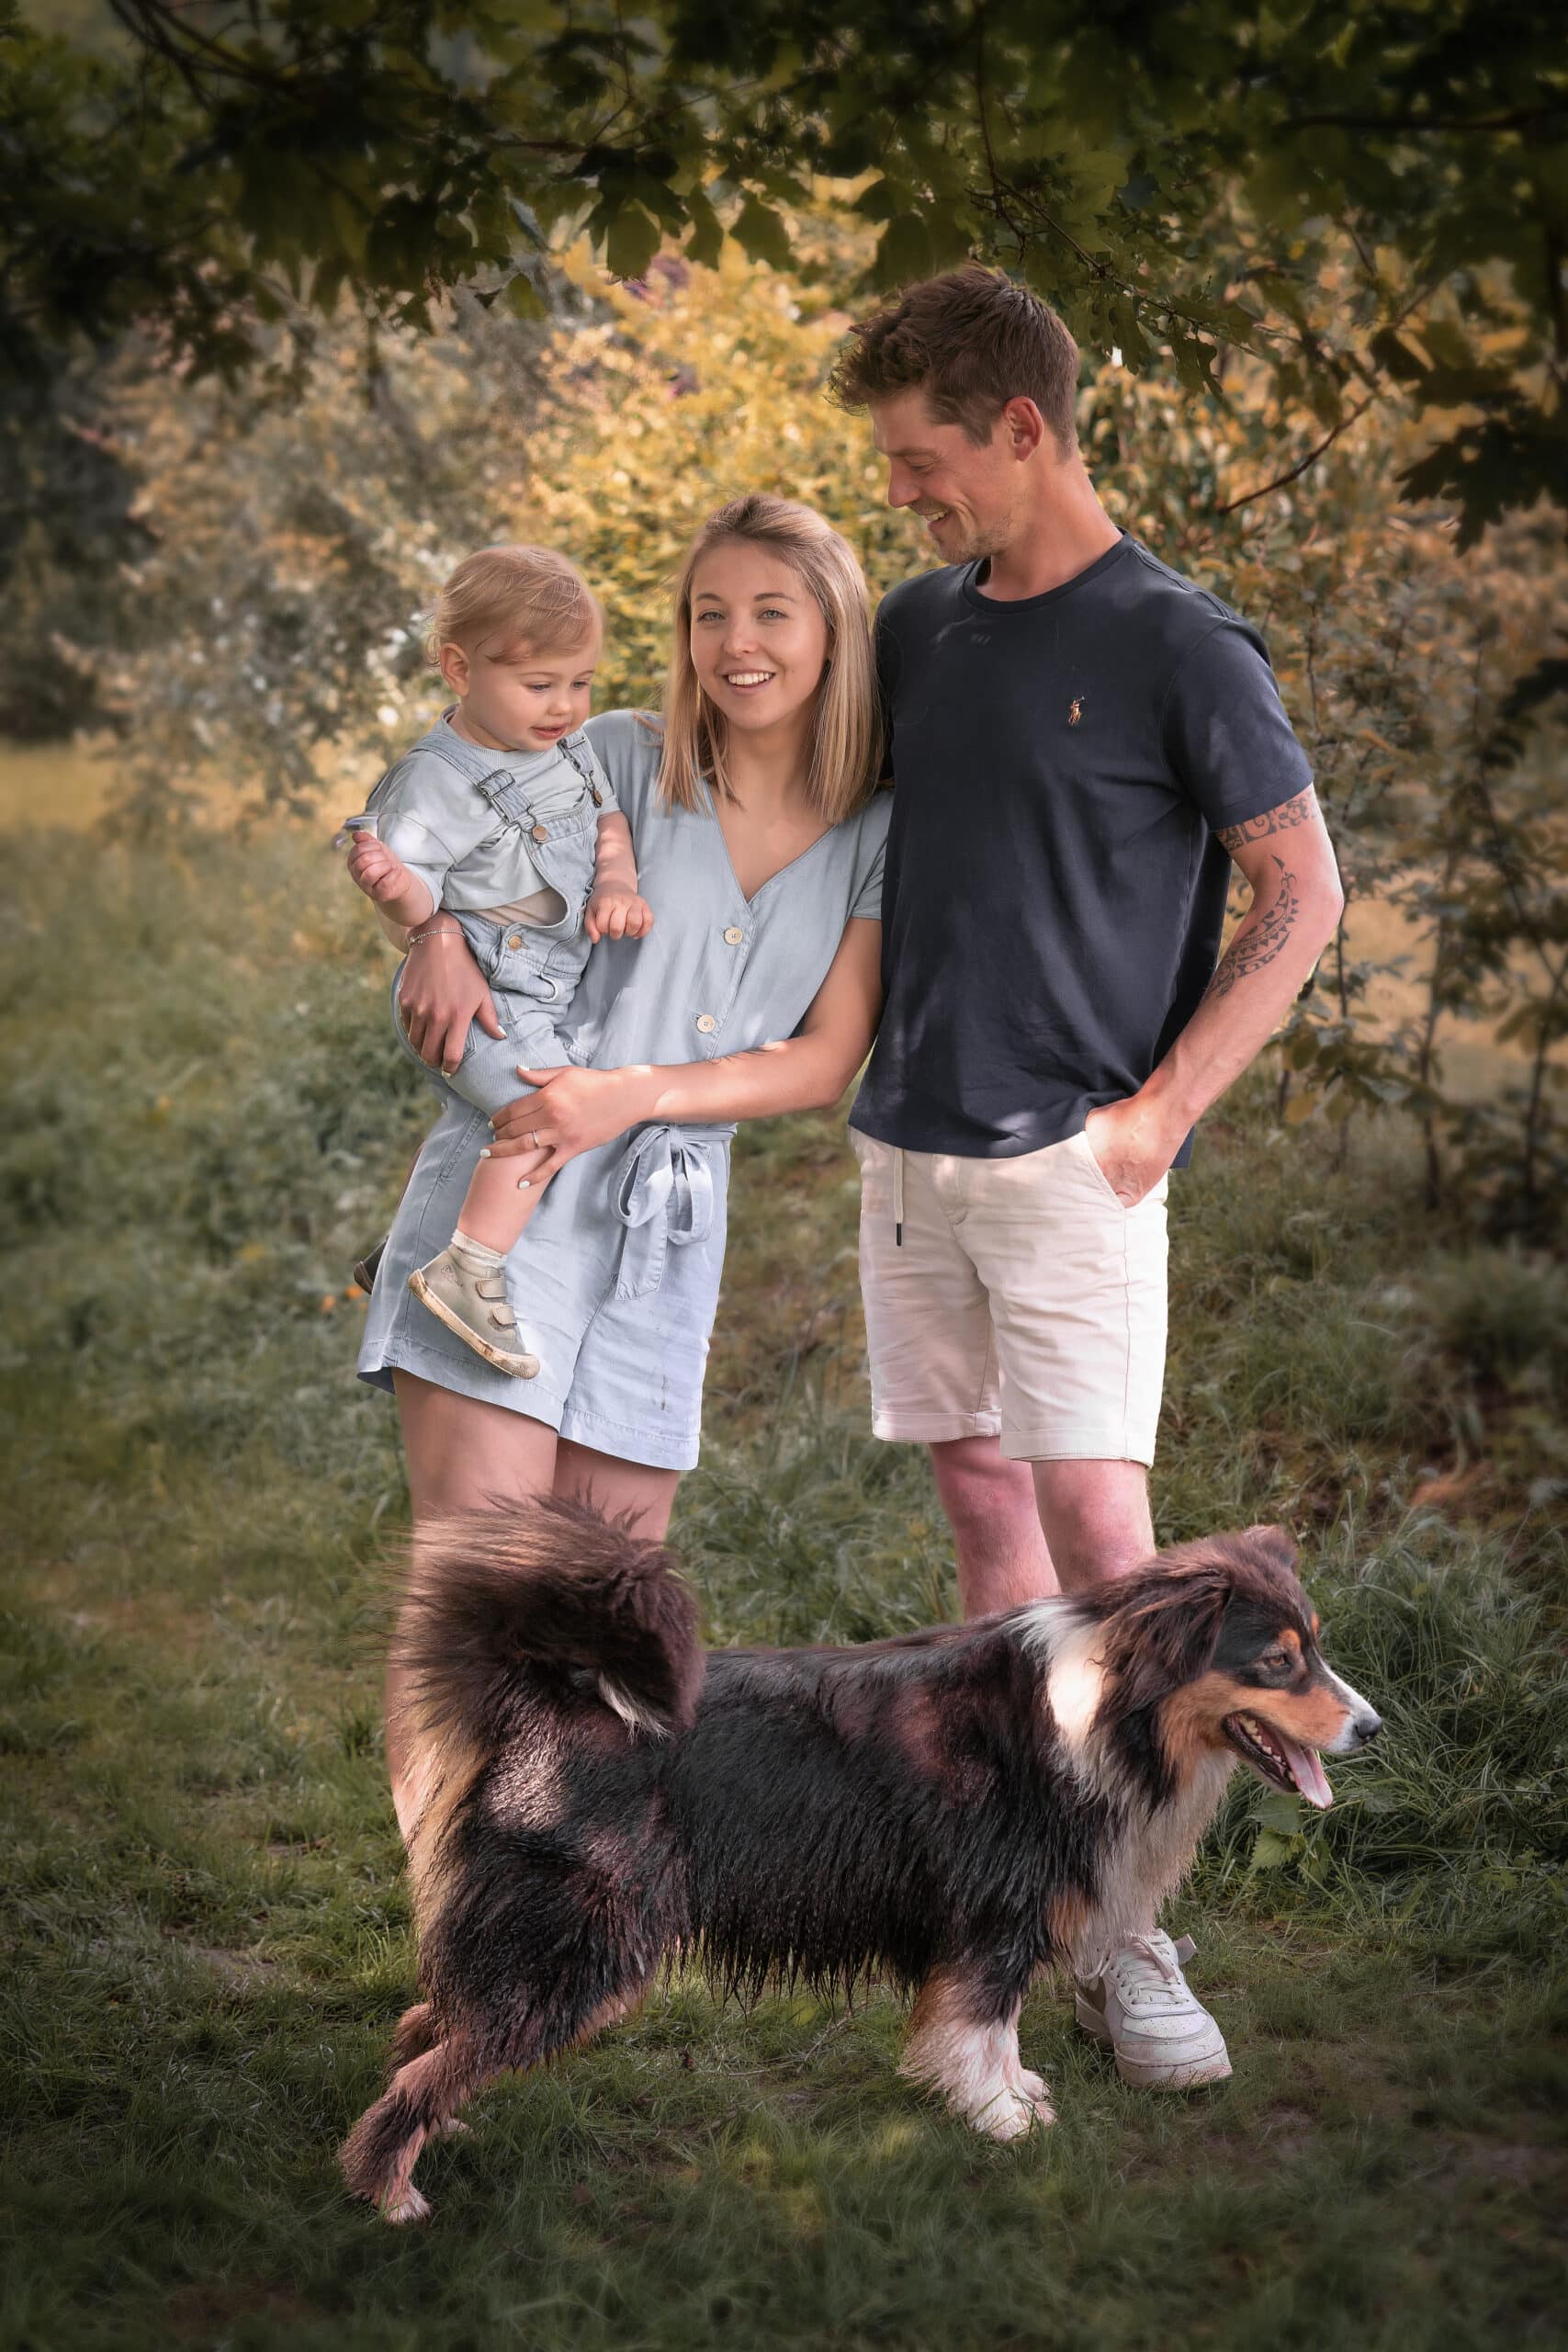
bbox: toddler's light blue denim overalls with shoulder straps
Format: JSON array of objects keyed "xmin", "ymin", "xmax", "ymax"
[{"xmin": 369, "ymin": 719, "xmax": 614, "ymax": 1113}]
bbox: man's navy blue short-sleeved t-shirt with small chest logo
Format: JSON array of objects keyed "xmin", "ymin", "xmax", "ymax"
[{"xmin": 851, "ymin": 537, "xmax": 1312, "ymax": 1159}]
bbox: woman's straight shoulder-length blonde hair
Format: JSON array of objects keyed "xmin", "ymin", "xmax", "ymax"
[{"xmin": 659, "ymin": 492, "xmax": 882, "ymax": 826}]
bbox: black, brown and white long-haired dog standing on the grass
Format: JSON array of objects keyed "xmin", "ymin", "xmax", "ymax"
[{"xmin": 341, "ymin": 1500, "xmax": 1380, "ymax": 2222}]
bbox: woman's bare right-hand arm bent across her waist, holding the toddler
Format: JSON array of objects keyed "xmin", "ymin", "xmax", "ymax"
[{"xmin": 491, "ymin": 917, "xmax": 882, "ymax": 1179}]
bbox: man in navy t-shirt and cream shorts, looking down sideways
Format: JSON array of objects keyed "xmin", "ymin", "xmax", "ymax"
[{"xmin": 832, "ymin": 264, "xmax": 1342, "ymax": 2088}]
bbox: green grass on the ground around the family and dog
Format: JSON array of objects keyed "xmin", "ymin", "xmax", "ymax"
[{"xmin": 0, "ymin": 813, "xmax": 1568, "ymax": 2352}]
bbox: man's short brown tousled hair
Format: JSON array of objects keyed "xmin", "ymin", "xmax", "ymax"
[{"xmin": 828, "ymin": 261, "xmax": 1079, "ymax": 457}]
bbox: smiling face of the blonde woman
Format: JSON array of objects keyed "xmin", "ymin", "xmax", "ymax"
[{"xmin": 691, "ymin": 538, "xmax": 828, "ymax": 731}]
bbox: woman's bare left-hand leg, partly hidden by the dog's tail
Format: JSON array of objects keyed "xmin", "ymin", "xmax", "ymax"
[{"xmin": 386, "ymin": 1371, "xmax": 558, "ymax": 1844}]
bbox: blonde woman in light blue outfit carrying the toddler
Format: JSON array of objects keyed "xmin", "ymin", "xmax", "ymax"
[{"xmin": 360, "ymin": 496, "xmax": 886, "ymax": 1830}]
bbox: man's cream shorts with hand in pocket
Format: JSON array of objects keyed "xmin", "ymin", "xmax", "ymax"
[{"xmin": 849, "ymin": 1126, "xmax": 1166, "ymax": 1463}]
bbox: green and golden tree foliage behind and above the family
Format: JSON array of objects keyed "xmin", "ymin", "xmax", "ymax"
[{"xmin": 0, "ymin": 0, "xmax": 1568, "ymax": 1226}]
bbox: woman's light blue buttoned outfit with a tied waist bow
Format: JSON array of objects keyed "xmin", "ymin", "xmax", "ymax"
[{"xmin": 360, "ymin": 710, "xmax": 888, "ymax": 1470}]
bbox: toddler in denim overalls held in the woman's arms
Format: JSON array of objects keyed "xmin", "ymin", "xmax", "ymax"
[{"xmin": 345, "ymin": 548, "xmax": 653, "ymax": 1381}]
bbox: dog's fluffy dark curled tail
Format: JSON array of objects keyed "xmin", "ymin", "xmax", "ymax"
[{"xmin": 395, "ymin": 1498, "xmax": 703, "ymax": 1746}]
